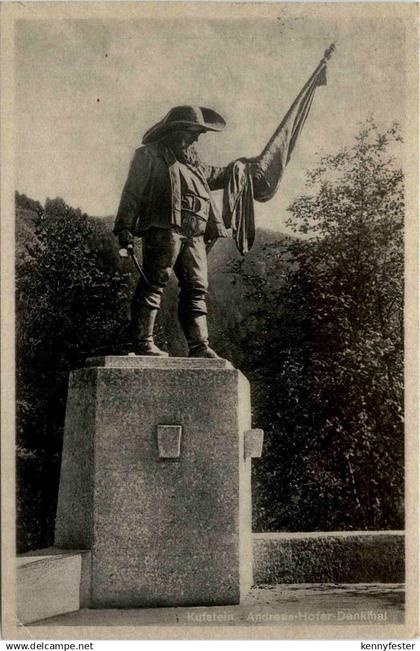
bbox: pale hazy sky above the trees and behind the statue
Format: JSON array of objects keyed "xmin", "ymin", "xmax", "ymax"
[{"xmin": 15, "ymin": 3, "xmax": 406, "ymax": 231}]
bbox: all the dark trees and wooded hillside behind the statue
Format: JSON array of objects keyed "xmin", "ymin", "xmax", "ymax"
[{"xmin": 16, "ymin": 121, "xmax": 404, "ymax": 550}]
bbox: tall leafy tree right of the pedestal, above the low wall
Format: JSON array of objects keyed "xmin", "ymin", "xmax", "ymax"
[{"xmin": 234, "ymin": 120, "xmax": 404, "ymax": 530}]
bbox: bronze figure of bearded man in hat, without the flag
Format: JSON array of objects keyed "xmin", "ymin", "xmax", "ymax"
[{"xmin": 114, "ymin": 106, "xmax": 231, "ymax": 358}]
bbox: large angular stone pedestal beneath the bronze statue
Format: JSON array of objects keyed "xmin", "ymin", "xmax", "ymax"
[{"xmin": 55, "ymin": 356, "xmax": 261, "ymax": 608}]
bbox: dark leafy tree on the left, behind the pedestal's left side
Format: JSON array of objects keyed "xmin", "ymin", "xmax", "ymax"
[{"xmin": 16, "ymin": 198, "xmax": 128, "ymax": 549}]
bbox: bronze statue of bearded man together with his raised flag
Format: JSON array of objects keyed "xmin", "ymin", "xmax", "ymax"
[{"xmin": 114, "ymin": 45, "xmax": 334, "ymax": 358}]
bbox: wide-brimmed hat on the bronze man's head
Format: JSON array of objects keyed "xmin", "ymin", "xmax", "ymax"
[{"xmin": 142, "ymin": 106, "xmax": 226, "ymax": 145}]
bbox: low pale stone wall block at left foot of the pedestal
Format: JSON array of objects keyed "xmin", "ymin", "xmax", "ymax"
[{"xmin": 16, "ymin": 548, "xmax": 89, "ymax": 624}]
